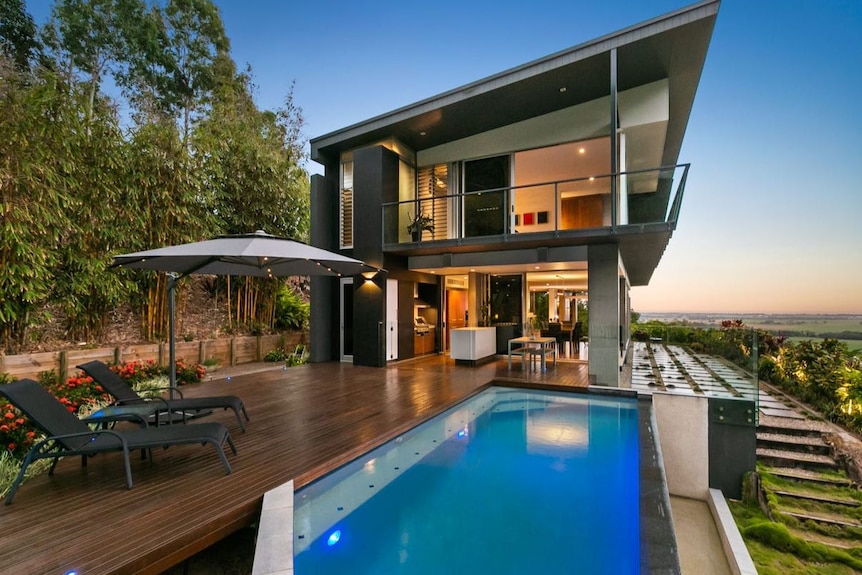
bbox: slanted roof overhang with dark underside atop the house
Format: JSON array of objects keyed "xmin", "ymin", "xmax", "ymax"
[{"xmin": 311, "ymin": 0, "xmax": 720, "ymax": 165}]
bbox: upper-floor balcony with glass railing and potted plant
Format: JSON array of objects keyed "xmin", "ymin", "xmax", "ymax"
[{"xmin": 382, "ymin": 164, "xmax": 689, "ymax": 251}]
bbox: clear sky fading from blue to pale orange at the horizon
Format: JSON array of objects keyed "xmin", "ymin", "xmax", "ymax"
[{"xmin": 27, "ymin": 0, "xmax": 862, "ymax": 314}]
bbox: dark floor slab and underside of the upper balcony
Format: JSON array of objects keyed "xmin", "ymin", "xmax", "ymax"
[{"xmin": 402, "ymin": 223, "xmax": 673, "ymax": 286}]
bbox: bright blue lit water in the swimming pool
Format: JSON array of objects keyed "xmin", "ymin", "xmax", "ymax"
[{"xmin": 294, "ymin": 388, "xmax": 640, "ymax": 575}]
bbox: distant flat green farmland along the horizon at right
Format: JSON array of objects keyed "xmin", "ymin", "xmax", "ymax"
[{"xmin": 640, "ymin": 312, "xmax": 862, "ymax": 350}]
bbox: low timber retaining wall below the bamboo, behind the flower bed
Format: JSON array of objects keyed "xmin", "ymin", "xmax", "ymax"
[{"xmin": 0, "ymin": 331, "xmax": 307, "ymax": 380}]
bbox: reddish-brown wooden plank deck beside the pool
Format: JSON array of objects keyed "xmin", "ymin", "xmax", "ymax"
[{"xmin": 0, "ymin": 356, "xmax": 589, "ymax": 575}]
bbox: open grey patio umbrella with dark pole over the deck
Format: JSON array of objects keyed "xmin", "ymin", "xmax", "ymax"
[{"xmin": 112, "ymin": 230, "xmax": 380, "ymax": 388}]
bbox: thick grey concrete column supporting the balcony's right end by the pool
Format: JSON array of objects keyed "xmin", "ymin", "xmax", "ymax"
[{"xmin": 587, "ymin": 244, "xmax": 621, "ymax": 387}]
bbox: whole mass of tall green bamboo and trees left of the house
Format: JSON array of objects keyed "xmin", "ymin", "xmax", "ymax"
[{"xmin": 0, "ymin": 0, "xmax": 310, "ymax": 353}]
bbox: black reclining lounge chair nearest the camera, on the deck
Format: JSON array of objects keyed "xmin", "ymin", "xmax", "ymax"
[{"xmin": 0, "ymin": 379, "xmax": 236, "ymax": 505}]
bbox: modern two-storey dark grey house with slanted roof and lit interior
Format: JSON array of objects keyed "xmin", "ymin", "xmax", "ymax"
[{"xmin": 311, "ymin": 0, "xmax": 719, "ymax": 385}]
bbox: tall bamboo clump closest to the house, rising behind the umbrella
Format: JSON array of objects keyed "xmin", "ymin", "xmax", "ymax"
[{"xmin": 192, "ymin": 62, "xmax": 309, "ymax": 326}]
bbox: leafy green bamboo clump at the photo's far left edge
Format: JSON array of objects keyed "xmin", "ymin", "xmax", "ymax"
[{"xmin": 0, "ymin": 71, "xmax": 75, "ymax": 353}]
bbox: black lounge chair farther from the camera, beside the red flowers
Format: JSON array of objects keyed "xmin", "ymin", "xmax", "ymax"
[{"xmin": 77, "ymin": 361, "xmax": 249, "ymax": 432}]
